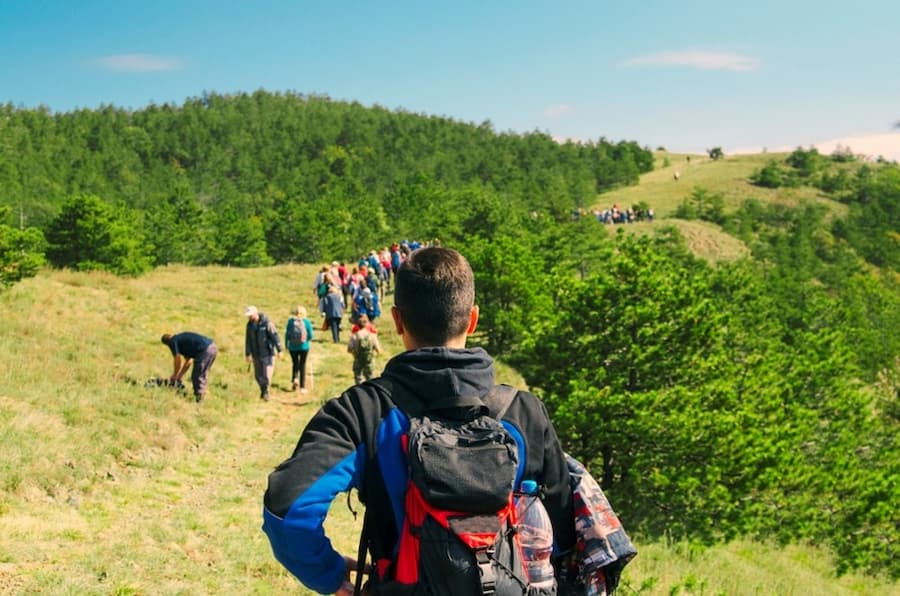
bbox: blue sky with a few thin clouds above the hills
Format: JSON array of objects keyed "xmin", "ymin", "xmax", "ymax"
[{"xmin": 0, "ymin": 0, "xmax": 900, "ymax": 159}]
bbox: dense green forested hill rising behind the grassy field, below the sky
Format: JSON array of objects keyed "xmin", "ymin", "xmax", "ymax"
[{"xmin": 0, "ymin": 91, "xmax": 653, "ymax": 273}]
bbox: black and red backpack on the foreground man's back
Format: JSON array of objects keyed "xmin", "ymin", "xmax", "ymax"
[{"xmin": 358, "ymin": 385, "xmax": 555, "ymax": 596}]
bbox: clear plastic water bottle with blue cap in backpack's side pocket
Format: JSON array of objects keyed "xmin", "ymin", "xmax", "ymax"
[{"xmin": 516, "ymin": 480, "xmax": 556, "ymax": 588}]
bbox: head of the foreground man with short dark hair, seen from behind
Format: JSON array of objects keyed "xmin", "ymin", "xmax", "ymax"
[{"xmin": 394, "ymin": 246, "xmax": 475, "ymax": 346}]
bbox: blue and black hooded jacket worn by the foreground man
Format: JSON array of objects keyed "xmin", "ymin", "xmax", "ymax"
[{"xmin": 263, "ymin": 348, "xmax": 575, "ymax": 594}]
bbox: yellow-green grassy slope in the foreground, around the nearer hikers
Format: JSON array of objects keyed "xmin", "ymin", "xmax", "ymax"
[{"xmin": 0, "ymin": 265, "xmax": 898, "ymax": 594}]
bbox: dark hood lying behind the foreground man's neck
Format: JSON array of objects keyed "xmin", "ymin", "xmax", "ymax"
[{"xmin": 381, "ymin": 348, "xmax": 494, "ymax": 404}]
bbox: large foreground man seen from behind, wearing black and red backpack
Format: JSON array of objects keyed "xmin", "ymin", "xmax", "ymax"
[{"xmin": 263, "ymin": 247, "xmax": 575, "ymax": 596}]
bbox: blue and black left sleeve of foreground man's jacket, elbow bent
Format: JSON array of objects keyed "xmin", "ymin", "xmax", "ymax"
[{"xmin": 263, "ymin": 393, "xmax": 365, "ymax": 594}]
